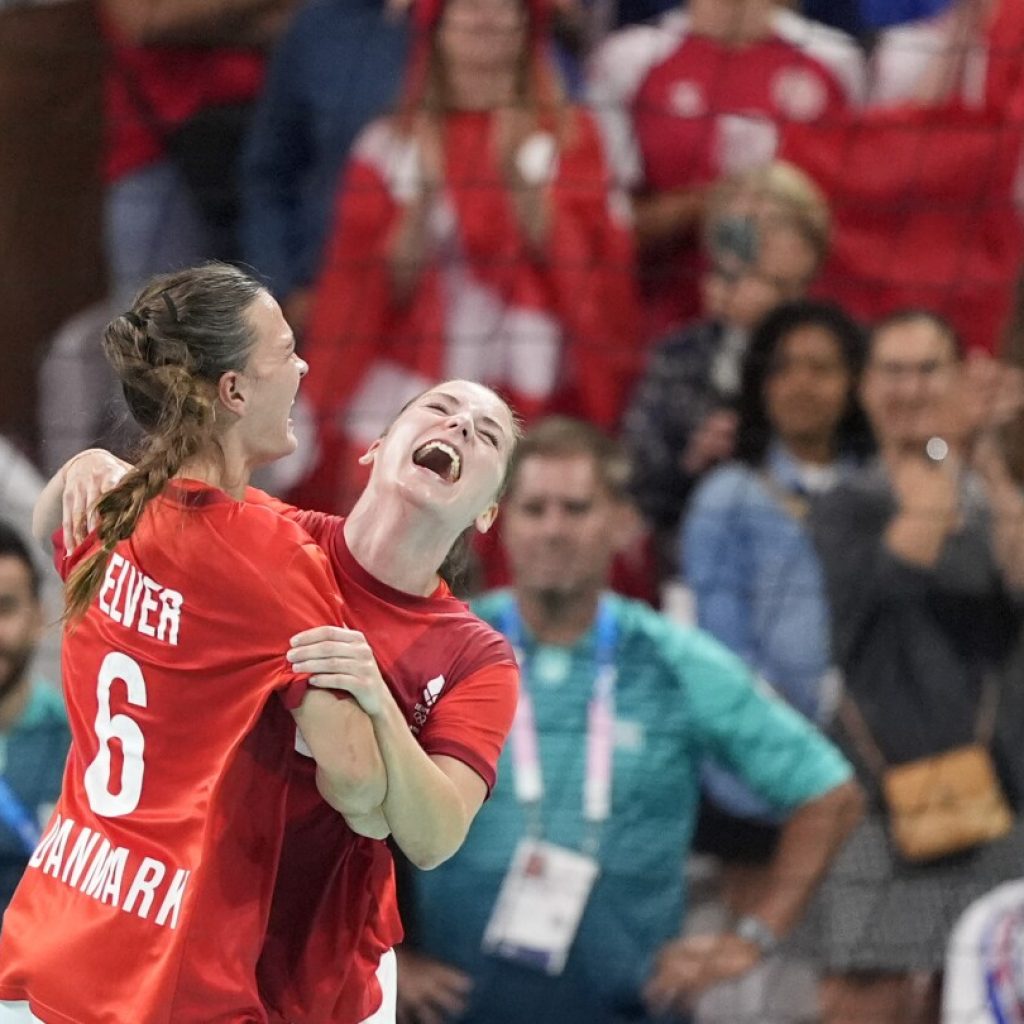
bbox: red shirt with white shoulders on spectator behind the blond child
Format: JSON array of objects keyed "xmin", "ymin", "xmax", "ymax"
[{"xmin": 592, "ymin": 9, "xmax": 865, "ymax": 333}]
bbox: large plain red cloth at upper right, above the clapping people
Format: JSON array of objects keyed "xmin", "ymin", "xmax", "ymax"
[{"xmin": 783, "ymin": 97, "xmax": 1024, "ymax": 351}]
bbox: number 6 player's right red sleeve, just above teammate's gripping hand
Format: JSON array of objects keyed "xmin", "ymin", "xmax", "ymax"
[{"xmin": 274, "ymin": 544, "xmax": 342, "ymax": 711}]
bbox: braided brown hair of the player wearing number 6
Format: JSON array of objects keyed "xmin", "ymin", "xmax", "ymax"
[{"xmin": 65, "ymin": 263, "xmax": 262, "ymax": 620}]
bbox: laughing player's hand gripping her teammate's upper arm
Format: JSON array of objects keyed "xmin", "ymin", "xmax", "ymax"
[{"xmin": 288, "ymin": 626, "xmax": 394, "ymax": 718}]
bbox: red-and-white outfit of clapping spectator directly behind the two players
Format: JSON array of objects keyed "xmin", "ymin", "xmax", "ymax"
[{"xmin": 292, "ymin": 111, "xmax": 640, "ymax": 511}]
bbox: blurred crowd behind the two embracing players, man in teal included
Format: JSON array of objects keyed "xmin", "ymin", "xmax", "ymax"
[{"xmin": 6, "ymin": 0, "xmax": 1024, "ymax": 1024}]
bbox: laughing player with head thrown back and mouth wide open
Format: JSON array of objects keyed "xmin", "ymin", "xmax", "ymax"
[{"xmin": 44, "ymin": 381, "xmax": 519, "ymax": 1024}]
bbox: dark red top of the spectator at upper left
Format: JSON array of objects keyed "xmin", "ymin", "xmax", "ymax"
[{"xmin": 101, "ymin": 19, "xmax": 265, "ymax": 181}]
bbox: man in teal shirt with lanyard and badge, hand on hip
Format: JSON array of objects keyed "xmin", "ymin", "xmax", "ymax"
[{"xmin": 399, "ymin": 419, "xmax": 860, "ymax": 1024}]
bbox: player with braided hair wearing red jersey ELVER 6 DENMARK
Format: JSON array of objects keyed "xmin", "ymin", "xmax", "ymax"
[{"xmin": 0, "ymin": 264, "xmax": 386, "ymax": 1024}]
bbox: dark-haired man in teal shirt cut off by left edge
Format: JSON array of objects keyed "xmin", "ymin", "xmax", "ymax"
[{"xmin": 0, "ymin": 520, "xmax": 71, "ymax": 911}]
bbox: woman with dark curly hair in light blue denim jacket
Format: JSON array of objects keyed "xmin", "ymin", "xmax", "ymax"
[{"xmin": 681, "ymin": 300, "xmax": 870, "ymax": 839}]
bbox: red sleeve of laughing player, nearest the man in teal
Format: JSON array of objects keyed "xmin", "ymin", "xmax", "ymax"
[{"xmin": 420, "ymin": 662, "xmax": 519, "ymax": 794}]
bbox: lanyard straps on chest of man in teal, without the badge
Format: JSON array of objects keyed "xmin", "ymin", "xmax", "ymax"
[{"xmin": 501, "ymin": 596, "xmax": 618, "ymax": 853}]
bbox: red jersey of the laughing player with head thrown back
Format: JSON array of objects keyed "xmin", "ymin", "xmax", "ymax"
[{"xmin": 252, "ymin": 492, "xmax": 519, "ymax": 1024}]
